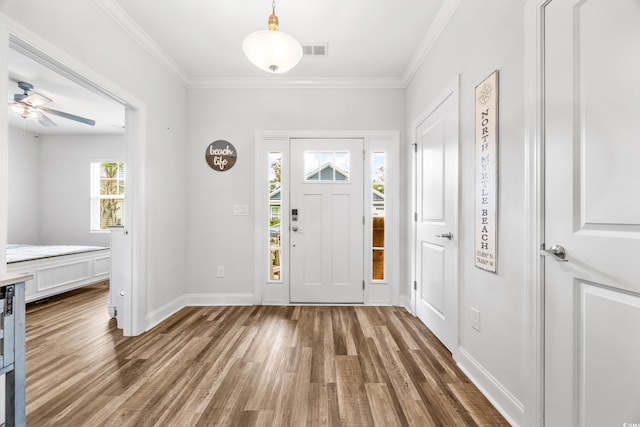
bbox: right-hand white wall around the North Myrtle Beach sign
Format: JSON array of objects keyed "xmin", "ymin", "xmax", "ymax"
[{"xmin": 402, "ymin": 0, "xmax": 526, "ymax": 424}]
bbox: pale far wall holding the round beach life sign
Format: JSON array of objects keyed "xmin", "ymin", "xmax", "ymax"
[{"xmin": 187, "ymin": 89, "xmax": 404, "ymax": 294}]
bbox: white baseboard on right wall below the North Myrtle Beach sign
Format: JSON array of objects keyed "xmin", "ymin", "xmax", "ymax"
[{"xmin": 455, "ymin": 347, "xmax": 524, "ymax": 427}]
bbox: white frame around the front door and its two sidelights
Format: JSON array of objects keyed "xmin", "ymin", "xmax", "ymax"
[{"xmin": 253, "ymin": 131, "xmax": 400, "ymax": 305}]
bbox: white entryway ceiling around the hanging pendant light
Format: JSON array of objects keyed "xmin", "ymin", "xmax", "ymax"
[{"xmin": 96, "ymin": 0, "xmax": 450, "ymax": 87}]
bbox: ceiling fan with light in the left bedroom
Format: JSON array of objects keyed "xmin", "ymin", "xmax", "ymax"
[{"xmin": 9, "ymin": 82, "xmax": 96, "ymax": 127}]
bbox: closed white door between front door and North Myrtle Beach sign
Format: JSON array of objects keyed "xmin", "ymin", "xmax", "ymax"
[{"xmin": 415, "ymin": 80, "xmax": 458, "ymax": 352}]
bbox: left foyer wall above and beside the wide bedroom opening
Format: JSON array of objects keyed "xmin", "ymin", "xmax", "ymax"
[{"xmin": 0, "ymin": 0, "xmax": 187, "ymax": 324}]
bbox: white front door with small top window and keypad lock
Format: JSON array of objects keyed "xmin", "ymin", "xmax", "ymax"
[{"xmin": 289, "ymin": 139, "xmax": 364, "ymax": 303}]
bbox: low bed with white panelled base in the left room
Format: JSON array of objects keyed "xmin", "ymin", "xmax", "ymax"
[{"xmin": 7, "ymin": 244, "xmax": 111, "ymax": 302}]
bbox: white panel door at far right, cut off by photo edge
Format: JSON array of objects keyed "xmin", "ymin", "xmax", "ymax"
[{"xmin": 543, "ymin": 0, "xmax": 640, "ymax": 427}]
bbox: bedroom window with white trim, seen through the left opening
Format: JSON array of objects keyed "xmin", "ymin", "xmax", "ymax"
[{"xmin": 90, "ymin": 162, "xmax": 125, "ymax": 231}]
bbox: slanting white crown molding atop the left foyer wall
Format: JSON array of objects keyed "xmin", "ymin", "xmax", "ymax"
[{"xmin": 94, "ymin": 0, "xmax": 189, "ymax": 86}]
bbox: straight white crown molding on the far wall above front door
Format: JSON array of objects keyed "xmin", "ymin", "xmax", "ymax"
[{"xmin": 187, "ymin": 76, "xmax": 406, "ymax": 89}]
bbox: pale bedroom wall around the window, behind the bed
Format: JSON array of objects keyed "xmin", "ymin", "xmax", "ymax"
[{"xmin": 37, "ymin": 135, "xmax": 125, "ymax": 246}]
